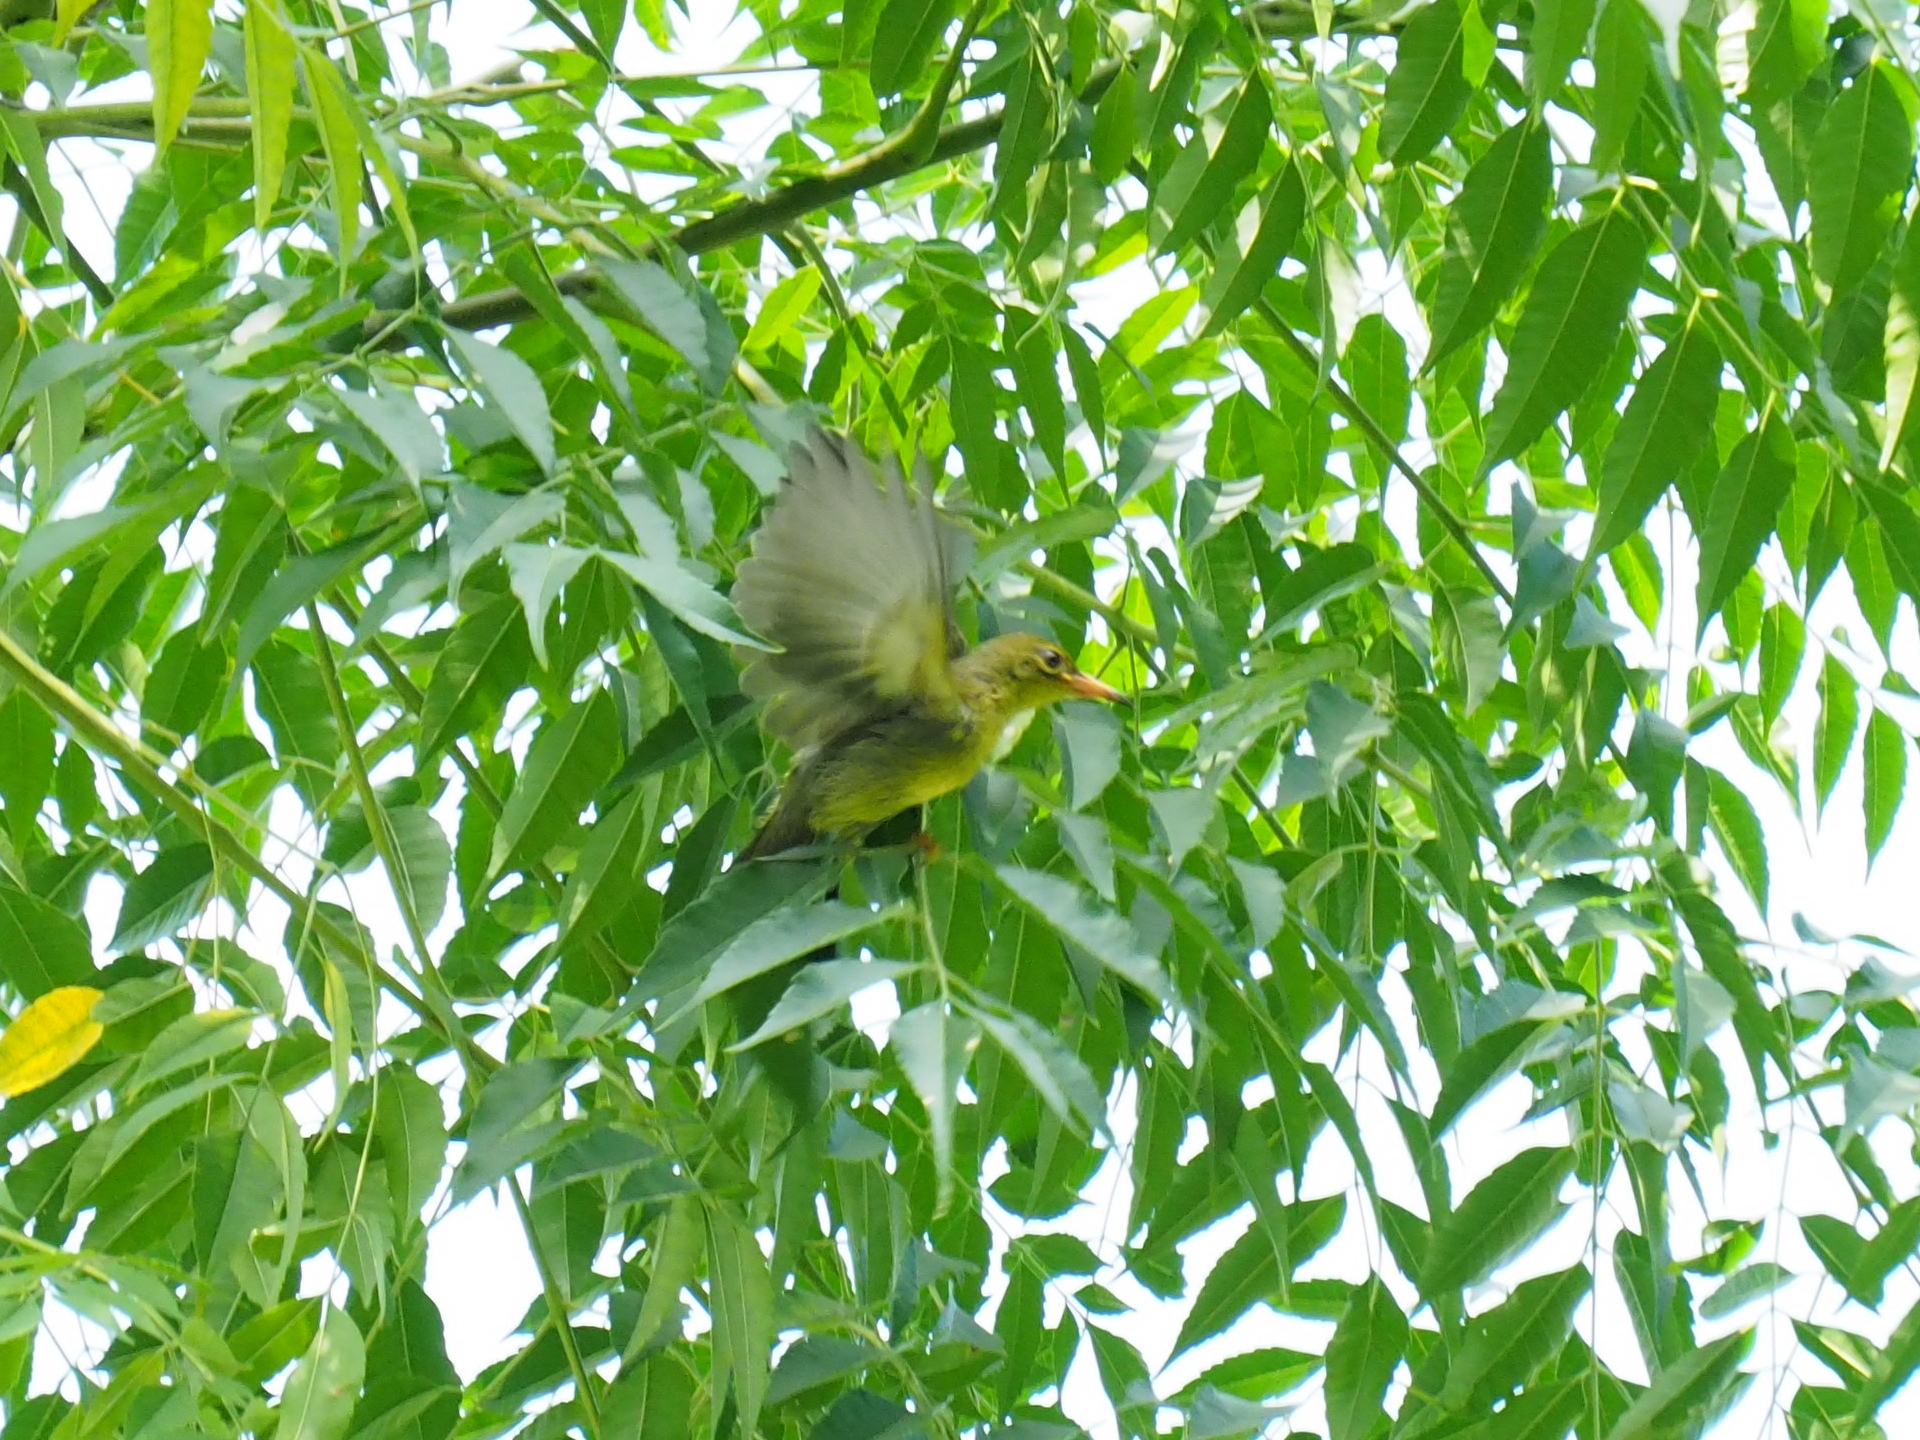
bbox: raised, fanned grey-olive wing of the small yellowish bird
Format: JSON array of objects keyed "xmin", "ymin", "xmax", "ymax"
[{"xmin": 733, "ymin": 430, "xmax": 968, "ymax": 749}]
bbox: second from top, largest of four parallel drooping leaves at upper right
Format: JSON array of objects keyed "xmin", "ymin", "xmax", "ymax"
[{"xmin": 1486, "ymin": 205, "xmax": 1647, "ymax": 465}]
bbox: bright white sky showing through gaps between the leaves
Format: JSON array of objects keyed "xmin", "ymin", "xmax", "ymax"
[{"xmin": 22, "ymin": 0, "xmax": 1920, "ymax": 1440}]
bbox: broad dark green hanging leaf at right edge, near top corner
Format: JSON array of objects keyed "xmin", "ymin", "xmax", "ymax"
[{"xmin": 1807, "ymin": 61, "xmax": 1920, "ymax": 294}]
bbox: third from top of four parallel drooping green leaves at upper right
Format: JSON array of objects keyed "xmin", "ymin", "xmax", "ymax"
[{"xmin": 1588, "ymin": 319, "xmax": 1720, "ymax": 555}]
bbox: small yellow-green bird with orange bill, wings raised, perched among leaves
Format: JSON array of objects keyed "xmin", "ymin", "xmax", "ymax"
[{"xmin": 732, "ymin": 426, "xmax": 1125, "ymax": 864}]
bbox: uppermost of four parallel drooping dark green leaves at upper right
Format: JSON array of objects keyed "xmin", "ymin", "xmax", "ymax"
[{"xmin": 1427, "ymin": 123, "xmax": 1553, "ymax": 371}]
